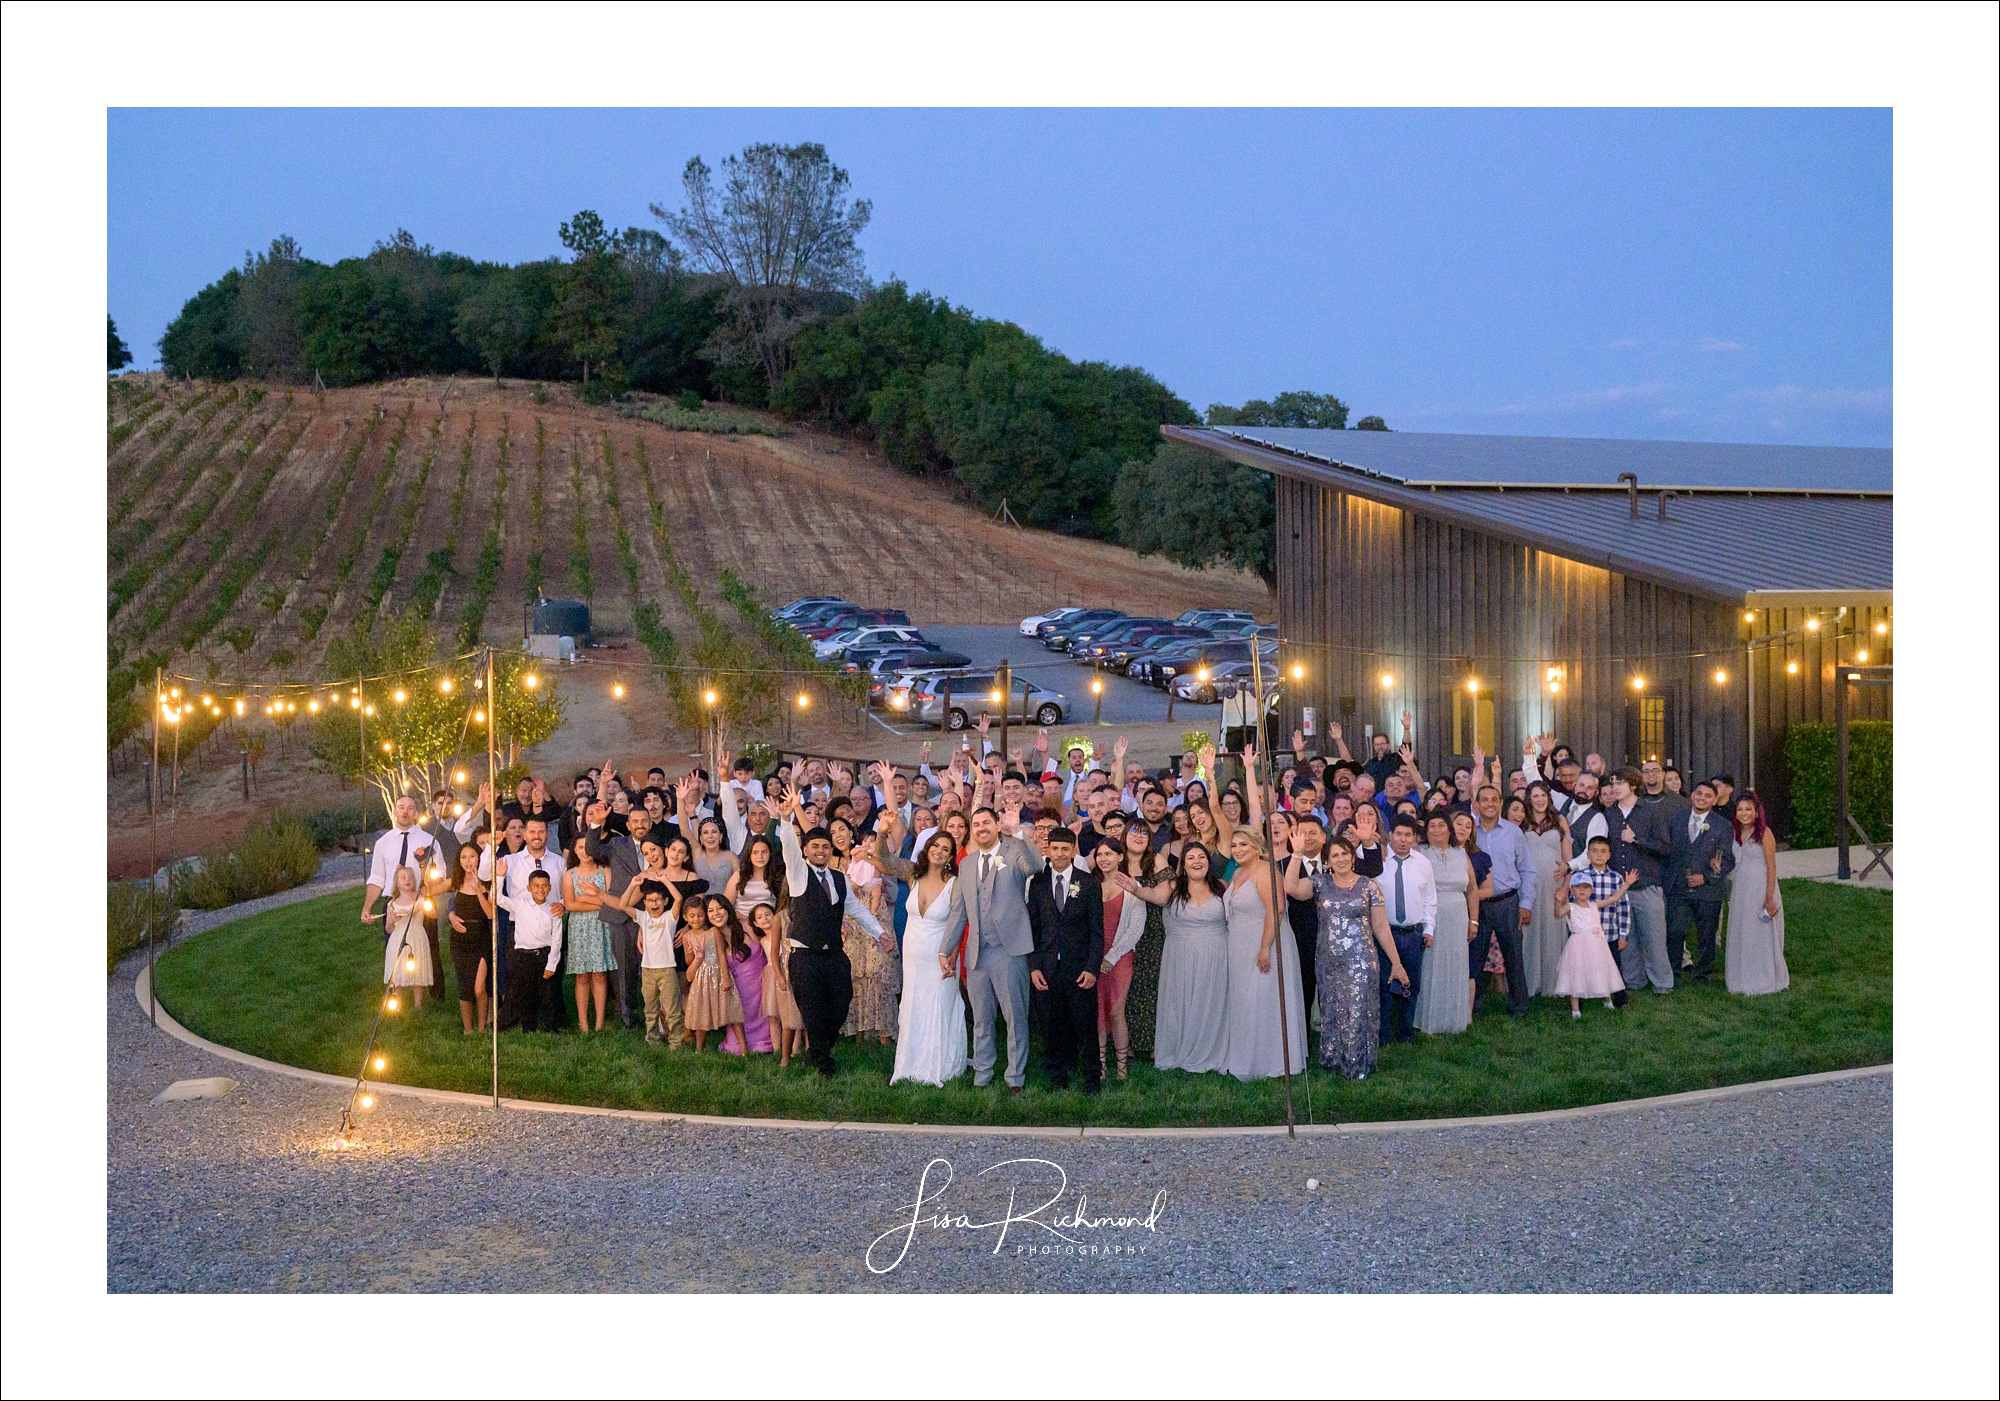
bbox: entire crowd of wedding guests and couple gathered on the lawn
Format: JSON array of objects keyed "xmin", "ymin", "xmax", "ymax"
[{"xmin": 362, "ymin": 713, "xmax": 1788, "ymax": 1095}]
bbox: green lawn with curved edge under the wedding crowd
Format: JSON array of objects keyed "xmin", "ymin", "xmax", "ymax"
[{"xmin": 158, "ymin": 881, "xmax": 1892, "ymax": 1125}]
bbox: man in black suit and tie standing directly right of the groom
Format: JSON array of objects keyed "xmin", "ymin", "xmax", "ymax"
[{"xmin": 1028, "ymin": 827, "xmax": 1104, "ymax": 1095}]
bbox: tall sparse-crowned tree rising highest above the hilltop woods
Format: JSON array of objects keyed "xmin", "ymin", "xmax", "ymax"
[{"xmin": 652, "ymin": 142, "xmax": 872, "ymax": 400}]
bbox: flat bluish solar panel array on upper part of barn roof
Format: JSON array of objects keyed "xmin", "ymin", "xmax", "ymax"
[{"xmin": 1214, "ymin": 428, "xmax": 1894, "ymax": 492}]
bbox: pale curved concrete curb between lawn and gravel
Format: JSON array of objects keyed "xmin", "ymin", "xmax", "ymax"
[{"xmin": 132, "ymin": 969, "xmax": 1896, "ymax": 1139}]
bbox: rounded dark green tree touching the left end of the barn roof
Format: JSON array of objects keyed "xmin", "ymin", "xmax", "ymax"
[{"xmin": 1116, "ymin": 442, "xmax": 1278, "ymax": 586}]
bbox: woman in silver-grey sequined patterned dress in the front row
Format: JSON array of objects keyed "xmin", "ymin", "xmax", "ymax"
[{"xmin": 1284, "ymin": 837, "xmax": 1408, "ymax": 1081}]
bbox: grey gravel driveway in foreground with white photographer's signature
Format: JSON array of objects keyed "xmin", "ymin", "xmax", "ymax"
[{"xmin": 106, "ymin": 959, "xmax": 1892, "ymax": 1293}]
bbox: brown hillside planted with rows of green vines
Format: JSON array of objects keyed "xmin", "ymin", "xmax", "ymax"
[{"xmin": 106, "ymin": 374, "xmax": 1270, "ymax": 676}]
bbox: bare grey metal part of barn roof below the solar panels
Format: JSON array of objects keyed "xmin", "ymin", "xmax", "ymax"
[{"xmin": 1164, "ymin": 426, "xmax": 1894, "ymax": 606}]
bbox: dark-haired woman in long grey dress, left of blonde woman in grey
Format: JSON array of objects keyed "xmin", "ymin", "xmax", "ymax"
[{"xmin": 1116, "ymin": 841, "xmax": 1230, "ymax": 1071}]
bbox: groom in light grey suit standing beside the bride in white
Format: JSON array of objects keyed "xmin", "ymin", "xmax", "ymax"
[{"xmin": 876, "ymin": 792, "xmax": 1046, "ymax": 1095}]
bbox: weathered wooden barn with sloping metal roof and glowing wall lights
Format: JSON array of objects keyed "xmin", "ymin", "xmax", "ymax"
[{"xmin": 1164, "ymin": 426, "xmax": 1894, "ymax": 831}]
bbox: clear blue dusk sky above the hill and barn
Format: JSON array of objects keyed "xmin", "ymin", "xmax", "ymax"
[{"xmin": 108, "ymin": 110, "xmax": 1892, "ymax": 446}]
